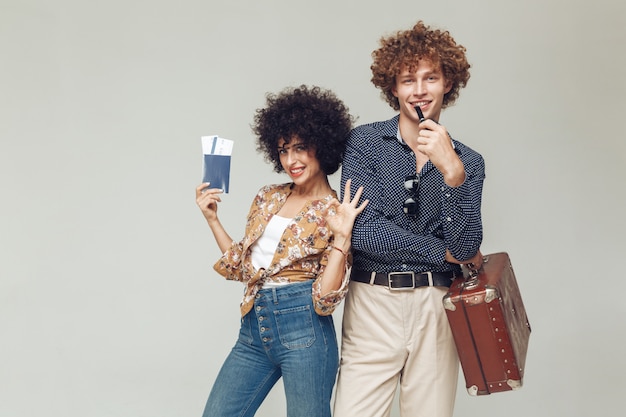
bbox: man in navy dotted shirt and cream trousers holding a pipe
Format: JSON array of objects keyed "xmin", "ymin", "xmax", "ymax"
[{"xmin": 334, "ymin": 21, "xmax": 485, "ymax": 417}]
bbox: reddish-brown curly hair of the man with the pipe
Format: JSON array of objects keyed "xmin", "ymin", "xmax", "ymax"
[{"xmin": 370, "ymin": 20, "xmax": 470, "ymax": 110}]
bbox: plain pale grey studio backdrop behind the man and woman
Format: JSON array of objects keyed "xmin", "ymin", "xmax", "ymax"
[{"xmin": 0, "ymin": 0, "xmax": 626, "ymax": 417}]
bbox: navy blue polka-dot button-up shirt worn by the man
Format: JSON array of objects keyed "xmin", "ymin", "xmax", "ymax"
[{"xmin": 341, "ymin": 116, "xmax": 485, "ymax": 272}]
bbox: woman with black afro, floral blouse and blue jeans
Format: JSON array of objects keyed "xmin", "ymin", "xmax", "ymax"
[{"xmin": 196, "ymin": 86, "xmax": 367, "ymax": 417}]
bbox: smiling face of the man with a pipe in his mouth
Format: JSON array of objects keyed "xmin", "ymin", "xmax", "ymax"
[{"xmin": 392, "ymin": 59, "xmax": 452, "ymax": 123}]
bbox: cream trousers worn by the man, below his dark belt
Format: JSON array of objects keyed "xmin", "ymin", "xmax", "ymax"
[{"xmin": 333, "ymin": 282, "xmax": 459, "ymax": 417}]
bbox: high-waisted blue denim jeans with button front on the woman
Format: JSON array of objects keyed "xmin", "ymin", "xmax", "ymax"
[{"xmin": 203, "ymin": 281, "xmax": 339, "ymax": 417}]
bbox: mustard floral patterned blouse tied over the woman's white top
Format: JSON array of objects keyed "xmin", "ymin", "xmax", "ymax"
[{"xmin": 213, "ymin": 183, "xmax": 352, "ymax": 316}]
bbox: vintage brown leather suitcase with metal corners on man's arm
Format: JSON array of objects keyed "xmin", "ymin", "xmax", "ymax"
[{"xmin": 443, "ymin": 252, "xmax": 530, "ymax": 395}]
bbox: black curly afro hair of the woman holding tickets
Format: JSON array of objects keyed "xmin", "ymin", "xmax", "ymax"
[{"xmin": 252, "ymin": 85, "xmax": 354, "ymax": 175}]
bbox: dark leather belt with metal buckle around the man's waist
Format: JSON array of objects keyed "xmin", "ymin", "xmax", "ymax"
[{"xmin": 350, "ymin": 270, "xmax": 455, "ymax": 291}]
